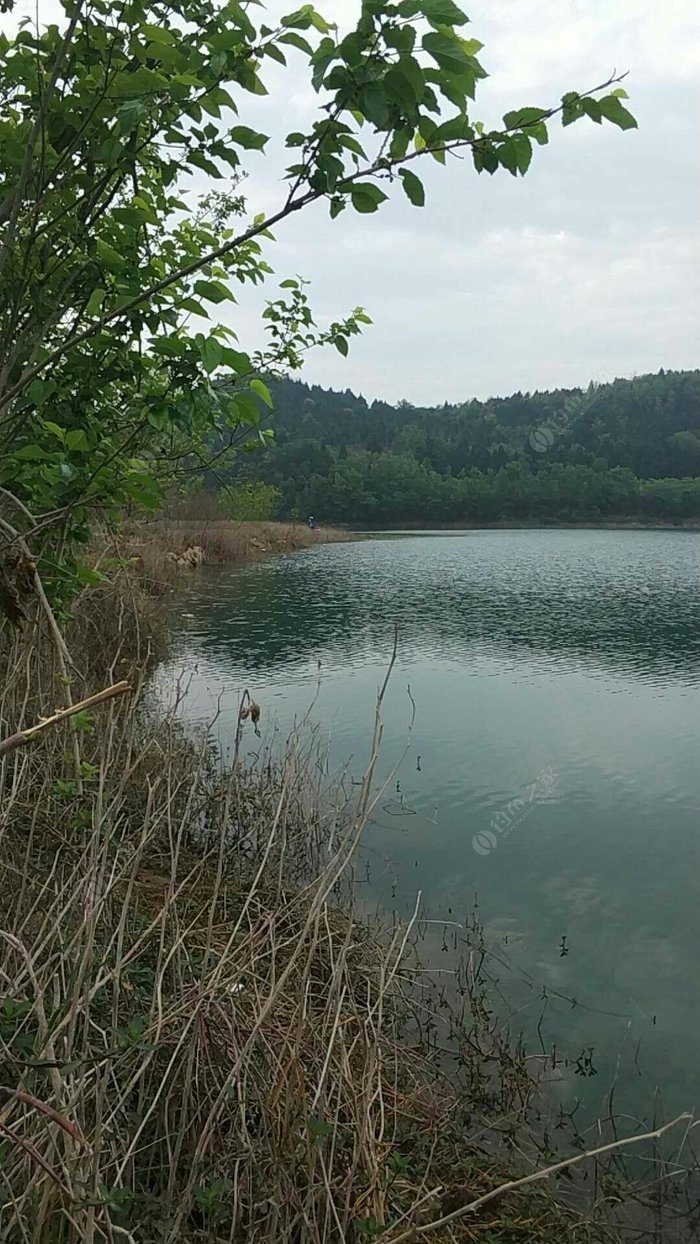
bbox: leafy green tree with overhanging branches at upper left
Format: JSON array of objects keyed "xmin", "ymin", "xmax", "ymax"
[{"xmin": 0, "ymin": 0, "xmax": 634, "ymax": 601}]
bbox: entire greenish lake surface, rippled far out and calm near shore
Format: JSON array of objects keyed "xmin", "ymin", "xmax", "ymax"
[{"xmin": 157, "ymin": 530, "xmax": 700, "ymax": 1115}]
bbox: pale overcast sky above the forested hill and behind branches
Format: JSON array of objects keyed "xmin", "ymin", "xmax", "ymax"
[{"xmin": 5, "ymin": 0, "xmax": 700, "ymax": 404}]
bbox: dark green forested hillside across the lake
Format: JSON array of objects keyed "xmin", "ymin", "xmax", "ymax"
[{"xmin": 208, "ymin": 371, "xmax": 700, "ymax": 524}]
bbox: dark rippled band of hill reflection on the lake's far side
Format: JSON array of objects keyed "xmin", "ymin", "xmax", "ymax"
[{"xmin": 165, "ymin": 531, "xmax": 700, "ymax": 682}]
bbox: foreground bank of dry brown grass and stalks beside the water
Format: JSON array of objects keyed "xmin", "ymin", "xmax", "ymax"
[{"xmin": 0, "ymin": 577, "xmax": 696, "ymax": 1244}]
